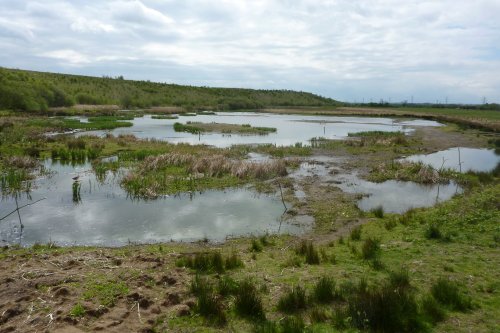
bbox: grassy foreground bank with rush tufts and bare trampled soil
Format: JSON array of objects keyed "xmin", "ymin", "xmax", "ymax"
[{"xmin": 0, "ymin": 186, "xmax": 500, "ymax": 332}]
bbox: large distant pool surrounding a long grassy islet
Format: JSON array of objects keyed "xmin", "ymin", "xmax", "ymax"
[{"xmin": 78, "ymin": 112, "xmax": 440, "ymax": 148}]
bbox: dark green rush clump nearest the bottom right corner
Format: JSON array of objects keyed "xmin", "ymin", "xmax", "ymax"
[{"xmin": 431, "ymin": 278, "xmax": 472, "ymax": 312}]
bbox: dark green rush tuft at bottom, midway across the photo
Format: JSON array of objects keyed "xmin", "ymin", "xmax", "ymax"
[{"xmin": 234, "ymin": 279, "xmax": 265, "ymax": 319}]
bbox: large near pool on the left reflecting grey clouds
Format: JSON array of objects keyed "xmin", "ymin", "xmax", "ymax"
[{"xmin": 0, "ymin": 162, "xmax": 303, "ymax": 246}]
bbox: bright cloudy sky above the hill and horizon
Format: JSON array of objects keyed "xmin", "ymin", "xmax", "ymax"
[{"xmin": 0, "ymin": 0, "xmax": 500, "ymax": 103}]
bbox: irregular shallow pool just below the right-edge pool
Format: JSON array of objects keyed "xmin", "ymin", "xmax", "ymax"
[{"xmin": 336, "ymin": 174, "xmax": 462, "ymax": 214}]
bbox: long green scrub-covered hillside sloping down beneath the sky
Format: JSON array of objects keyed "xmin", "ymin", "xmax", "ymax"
[{"xmin": 0, "ymin": 68, "xmax": 338, "ymax": 111}]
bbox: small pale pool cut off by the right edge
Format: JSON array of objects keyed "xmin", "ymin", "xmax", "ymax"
[{"xmin": 404, "ymin": 147, "xmax": 500, "ymax": 172}]
